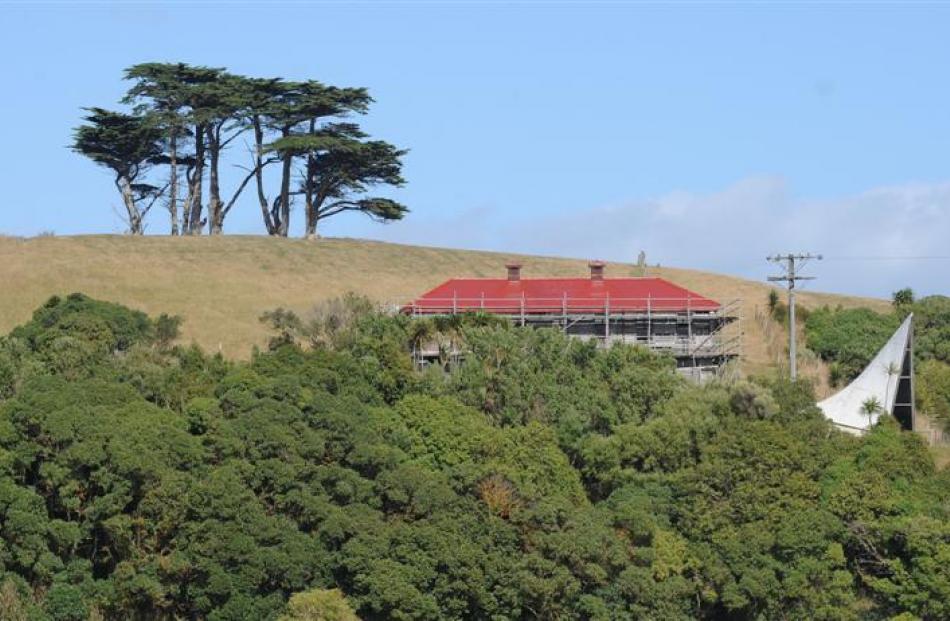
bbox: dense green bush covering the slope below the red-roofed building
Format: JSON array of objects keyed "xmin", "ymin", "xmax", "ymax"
[{"xmin": 0, "ymin": 296, "xmax": 950, "ymax": 621}]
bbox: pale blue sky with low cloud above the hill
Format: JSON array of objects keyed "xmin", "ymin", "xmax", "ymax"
[{"xmin": 0, "ymin": 2, "xmax": 950, "ymax": 296}]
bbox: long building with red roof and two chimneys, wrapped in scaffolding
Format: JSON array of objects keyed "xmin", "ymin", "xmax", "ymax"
[{"xmin": 402, "ymin": 261, "xmax": 738, "ymax": 379}]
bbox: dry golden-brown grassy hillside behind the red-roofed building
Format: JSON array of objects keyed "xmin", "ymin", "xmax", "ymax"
[{"xmin": 0, "ymin": 235, "xmax": 886, "ymax": 382}]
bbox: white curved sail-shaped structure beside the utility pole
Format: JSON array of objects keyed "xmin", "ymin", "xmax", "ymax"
[{"xmin": 818, "ymin": 314, "xmax": 913, "ymax": 434}]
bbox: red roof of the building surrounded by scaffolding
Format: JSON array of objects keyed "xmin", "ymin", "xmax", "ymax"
[{"xmin": 406, "ymin": 278, "xmax": 720, "ymax": 313}]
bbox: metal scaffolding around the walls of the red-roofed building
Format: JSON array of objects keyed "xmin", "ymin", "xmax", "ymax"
[{"xmin": 400, "ymin": 294, "xmax": 742, "ymax": 382}]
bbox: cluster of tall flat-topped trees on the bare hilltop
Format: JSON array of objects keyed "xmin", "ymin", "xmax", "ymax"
[{"xmin": 73, "ymin": 62, "xmax": 408, "ymax": 238}]
